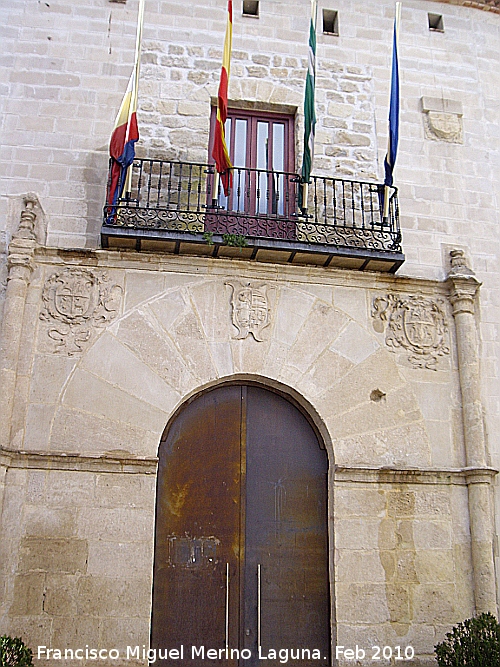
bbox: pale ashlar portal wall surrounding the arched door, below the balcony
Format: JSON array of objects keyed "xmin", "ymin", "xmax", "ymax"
[{"xmin": 0, "ymin": 250, "xmax": 480, "ymax": 665}]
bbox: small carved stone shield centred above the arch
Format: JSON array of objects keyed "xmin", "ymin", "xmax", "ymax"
[{"xmin": 225, "ymin": 280, "xmax": 271, "ymax": 342}]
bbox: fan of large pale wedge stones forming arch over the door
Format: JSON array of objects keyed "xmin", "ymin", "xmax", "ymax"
[{"xmin": 50, "ymin": 275, "xmax": 430, "ymax": 467}]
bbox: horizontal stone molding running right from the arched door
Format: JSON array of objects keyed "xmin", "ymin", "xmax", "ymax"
[{"xmin": 334, "ymin": 465, "xmax": 498, "ymax": 486}]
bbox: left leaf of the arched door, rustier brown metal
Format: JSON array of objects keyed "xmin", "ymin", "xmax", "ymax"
[{"xmin": 151, "ymin": 387, "xmax": 242, "ymax": 665}]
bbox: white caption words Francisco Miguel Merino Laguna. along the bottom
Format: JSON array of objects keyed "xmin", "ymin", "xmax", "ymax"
[{"xmin": 37, "ymin": 644, "xmax": 327, "ymax": 664}]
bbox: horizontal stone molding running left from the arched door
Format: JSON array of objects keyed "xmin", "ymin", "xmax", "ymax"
[{"xmin": 0, "ymin": 449, "xmax": 158, "ymax": 475}]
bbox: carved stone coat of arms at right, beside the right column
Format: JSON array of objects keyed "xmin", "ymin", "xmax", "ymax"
[{"xmin": 372, "ymin": 294, "xmax": 450, "ymax": 370}]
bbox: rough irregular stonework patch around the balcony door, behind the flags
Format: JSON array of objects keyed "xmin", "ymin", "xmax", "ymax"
[{"xmin": 140, "ymin": 40, "xmax": 377, "ymax": 179}]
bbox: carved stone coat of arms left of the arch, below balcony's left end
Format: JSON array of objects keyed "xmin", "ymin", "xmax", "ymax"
[{"xmin": 40, "ymin": 267, "xmax": 122, "ymax": 356}]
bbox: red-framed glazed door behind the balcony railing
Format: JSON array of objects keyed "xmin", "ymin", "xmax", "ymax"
[{"xmin": 209, "ymin": 109, "xmax": 296, "ymax": 224}]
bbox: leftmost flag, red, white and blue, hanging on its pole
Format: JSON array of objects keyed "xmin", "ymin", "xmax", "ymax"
[{"xmin": 108, "ymin": 0, "xmax": 145, "ymax": 206}]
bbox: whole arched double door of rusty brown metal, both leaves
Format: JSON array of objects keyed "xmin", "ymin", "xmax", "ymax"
[{"xmin": 151, "ymin": 385, "xmax": 330, "ymax": 667}]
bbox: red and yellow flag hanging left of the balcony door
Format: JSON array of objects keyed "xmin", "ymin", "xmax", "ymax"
[{"xmin": 212, "ymin": 0, "xmax": 233, "ymax": 197}]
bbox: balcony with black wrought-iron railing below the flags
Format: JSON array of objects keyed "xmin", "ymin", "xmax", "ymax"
[{"xmin": 101, "ymin": 159, "xmax": 404, "ymax": 272}]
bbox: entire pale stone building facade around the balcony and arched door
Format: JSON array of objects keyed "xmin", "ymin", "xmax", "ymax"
[{"xmin": 0, "ymin": 0, "xmax": 500, "ymax": 666}]
